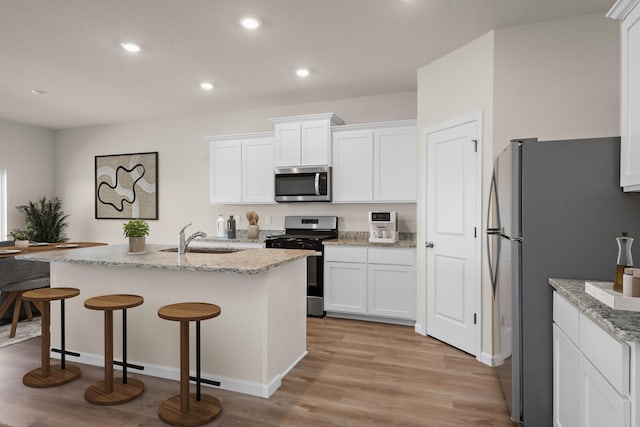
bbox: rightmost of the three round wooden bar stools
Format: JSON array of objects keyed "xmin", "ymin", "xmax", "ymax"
[{"xmin": 158, "ymin": 302, "xmax": 222, "ymax": 426}]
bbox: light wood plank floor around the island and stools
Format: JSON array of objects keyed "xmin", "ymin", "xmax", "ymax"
[{"xmin": 0, "ymin": 318, "xmax": 512, "ymax": 427}]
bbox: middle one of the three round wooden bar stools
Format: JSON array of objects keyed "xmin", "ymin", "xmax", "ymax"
[{"xmin": 84, "ymin": 294, "xmax": 144, "ymax": 405}]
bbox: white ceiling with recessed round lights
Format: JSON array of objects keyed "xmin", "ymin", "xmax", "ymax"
[{"xmin": 0, "ymin": 0, "xmax": 614, "ymax": 129}]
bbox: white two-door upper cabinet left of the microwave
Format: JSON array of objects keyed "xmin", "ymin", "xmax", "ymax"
[{"xmin": 209, "ymin": 133, "xmax": 275, "ymax": 204}]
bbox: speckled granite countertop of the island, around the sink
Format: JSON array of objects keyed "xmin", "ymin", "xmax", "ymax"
[{"xmin": 16, "ymin": 244, "xmax": 314, "ymax": 274}]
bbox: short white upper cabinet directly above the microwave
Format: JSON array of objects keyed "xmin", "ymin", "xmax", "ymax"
[{"xmin": 270, "ymin": 113, "xmax": 344, "ymax": 166}]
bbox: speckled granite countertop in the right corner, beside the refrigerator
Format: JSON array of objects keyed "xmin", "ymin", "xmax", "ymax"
[{"xmin": 549, "ymin": 278, "xmax": 640, "ymax": 341}]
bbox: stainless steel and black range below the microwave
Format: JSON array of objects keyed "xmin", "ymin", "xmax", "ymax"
[{"xmin": 265, "ymin": 216, "xmax": 338, "ymax": 317}]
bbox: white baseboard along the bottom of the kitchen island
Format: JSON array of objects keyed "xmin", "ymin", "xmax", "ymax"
[{"xmin": 51, "ymin": 350, "xmax": 308, "ymax": 399}]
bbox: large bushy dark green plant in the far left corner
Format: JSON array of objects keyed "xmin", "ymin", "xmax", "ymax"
[{"xmin": 17, "ymin": 197, "xmax": 69, "ymax": 243}]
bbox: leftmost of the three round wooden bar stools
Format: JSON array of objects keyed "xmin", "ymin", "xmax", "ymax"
[{"xmin": 22, "ymin": 288, "xmax": 80, "ymax": 388}]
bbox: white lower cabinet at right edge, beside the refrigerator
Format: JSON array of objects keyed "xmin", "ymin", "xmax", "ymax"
[{"xmin": 553, "ymin": 292, "xmax": 633, "ymax": 427}]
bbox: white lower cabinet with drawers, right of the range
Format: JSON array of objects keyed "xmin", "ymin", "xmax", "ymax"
[{"xmin": 324, "ymin": 245, "xmax": 416, "ymax": 321}]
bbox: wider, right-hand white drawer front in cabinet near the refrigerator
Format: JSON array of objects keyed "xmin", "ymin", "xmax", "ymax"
[{"xmin": 579, "ymin": 314, "xmax": 630, "ymax": 396}]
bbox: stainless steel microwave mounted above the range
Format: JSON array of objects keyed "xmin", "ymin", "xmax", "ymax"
[{"xmin": 274, "ymin": 166, "xmax": 331, "ymax": 202}]
